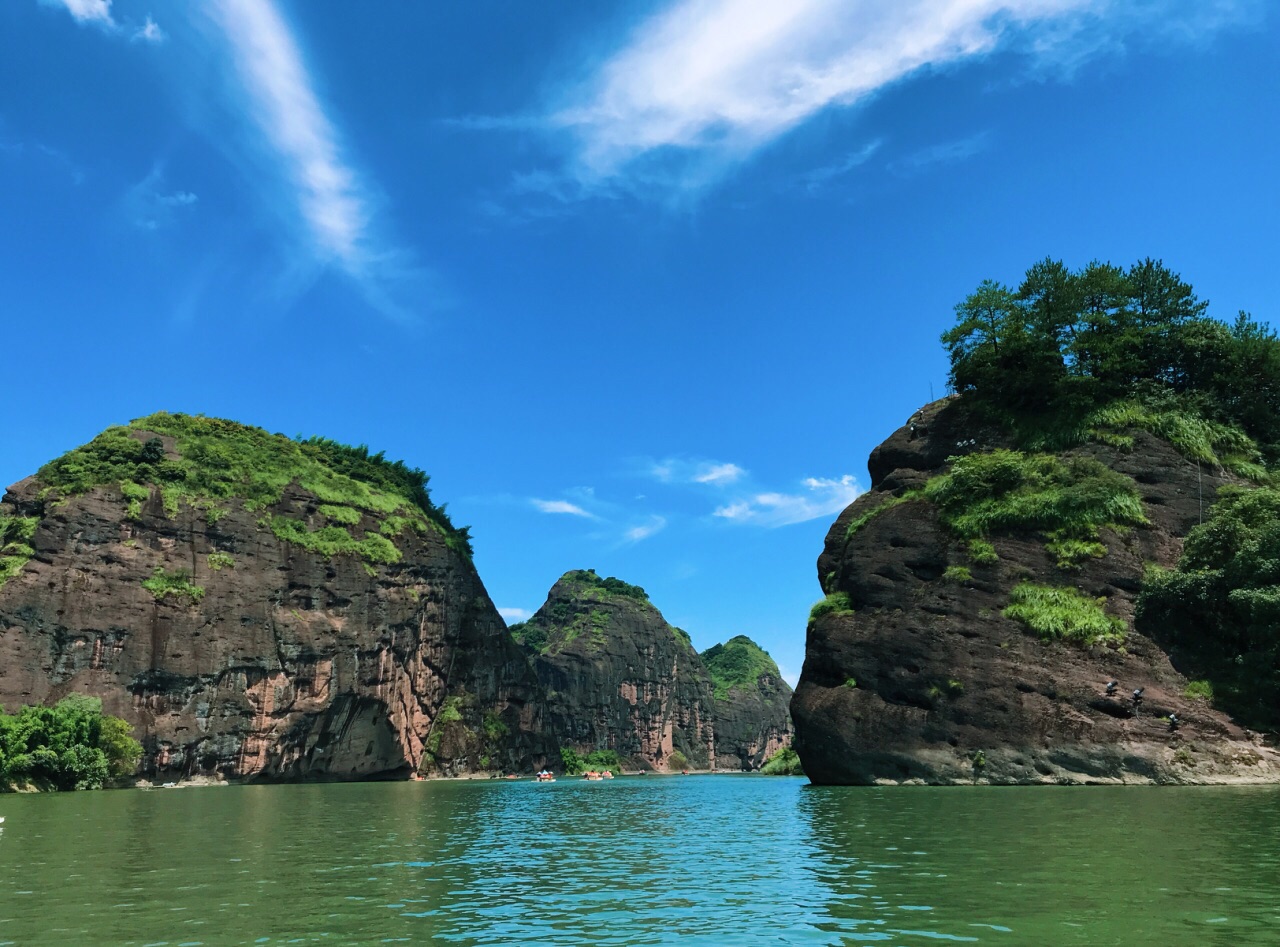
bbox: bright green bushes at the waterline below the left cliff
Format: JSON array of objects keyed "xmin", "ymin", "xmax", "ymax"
[{"xmin": 0, "ymin": 696, "xmax": 142, "ymax": 790}]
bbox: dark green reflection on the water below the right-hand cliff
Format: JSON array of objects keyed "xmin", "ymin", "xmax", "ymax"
[{"xmin": 799, "ymin": 787, "xmax": 1280, "ymax": 947}]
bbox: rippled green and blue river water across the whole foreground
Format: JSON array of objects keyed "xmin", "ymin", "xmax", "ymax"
[{"xmin": 0, "ymin": 776, "xmax": 1280, "ymax": 947}]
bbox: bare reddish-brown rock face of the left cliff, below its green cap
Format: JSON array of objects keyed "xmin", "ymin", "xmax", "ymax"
[{"xmin": 0, "ymin": 476, "xmax": 557, "ymax": 781}]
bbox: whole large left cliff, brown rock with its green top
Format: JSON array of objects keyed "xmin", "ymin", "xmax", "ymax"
[{"xmin": 0, "ymin": 413, "xmax": 557, "ymax": 781}]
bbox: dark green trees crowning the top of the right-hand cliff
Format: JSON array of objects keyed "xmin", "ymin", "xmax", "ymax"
[{"xmin": 942, "ymin": 259, "xmax": 1280, "ymax": 462}]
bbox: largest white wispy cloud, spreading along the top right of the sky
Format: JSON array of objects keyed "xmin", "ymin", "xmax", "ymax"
[{"xmin": 549, "ymin": 0, "xmax": 1258, "ymax": 184}]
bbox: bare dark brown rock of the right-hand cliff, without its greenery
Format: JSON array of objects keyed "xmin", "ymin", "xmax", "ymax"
[{"xmin": 791, "ymin": 399, "xmax": 1280, "ymax": 783}]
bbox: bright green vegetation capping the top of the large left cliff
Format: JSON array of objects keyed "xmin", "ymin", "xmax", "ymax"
[{"xmin": 22, "ymin": 412, "xmax": 471, "ymax": 563}]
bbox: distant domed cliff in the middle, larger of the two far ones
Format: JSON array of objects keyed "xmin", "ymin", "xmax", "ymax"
[{"xmin": 512, "ymin": 569, "xmax": 716, "ymax": 769}]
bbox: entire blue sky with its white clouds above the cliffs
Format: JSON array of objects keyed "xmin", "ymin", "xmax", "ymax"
[{"xmin": 0, "ymin": 0, "xmax": 1280, "ymax": 680}]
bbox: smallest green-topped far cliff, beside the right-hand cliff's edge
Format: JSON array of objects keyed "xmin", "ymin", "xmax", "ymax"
[{"xmin": 700, "ymin": 635, "xmax": 792, "ymax": 770}]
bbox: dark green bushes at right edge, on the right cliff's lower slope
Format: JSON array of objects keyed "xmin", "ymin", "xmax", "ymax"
[{"xmin": 1135, "ymin": 488, "xmax": 1280, "ymax": 728}]
